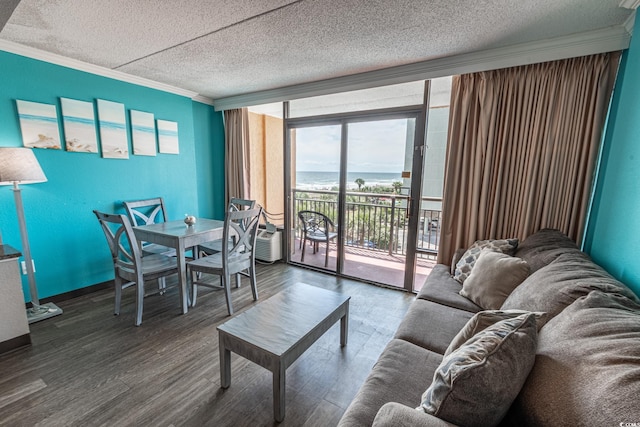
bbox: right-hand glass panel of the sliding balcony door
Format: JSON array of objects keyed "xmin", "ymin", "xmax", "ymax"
[{"xmin": 342, "ymin": 118, "xmax": 416, "ymax": 288}]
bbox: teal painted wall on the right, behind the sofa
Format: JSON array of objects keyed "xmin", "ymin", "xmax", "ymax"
[{"xmin": 584, "ymin": 27, "xmax": 640, "ymax": 295}]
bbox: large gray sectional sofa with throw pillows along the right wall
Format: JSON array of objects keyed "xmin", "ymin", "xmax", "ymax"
[{"xmin": 339, "ymin": 229, "xmax": 640, "ymax": 427}]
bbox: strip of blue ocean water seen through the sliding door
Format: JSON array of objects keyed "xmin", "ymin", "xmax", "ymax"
[{"xmin": 296, "ymin": 171, "xmax": 402, "ymax": 190}]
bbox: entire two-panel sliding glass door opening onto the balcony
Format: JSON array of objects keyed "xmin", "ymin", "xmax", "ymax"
[{"xmin": 285, "ymin": 106, "xmax": 424, "ymax": 290}]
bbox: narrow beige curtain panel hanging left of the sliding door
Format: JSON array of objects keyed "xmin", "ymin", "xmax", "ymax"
[{"xmin": 224, "ymin": 108, "xmax": 251, "ymax": 205}]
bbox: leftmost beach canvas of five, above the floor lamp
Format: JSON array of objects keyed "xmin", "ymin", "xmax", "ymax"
[{"xmin": 16, "ymin": 99, "xmax": 61, "ymax": 150}]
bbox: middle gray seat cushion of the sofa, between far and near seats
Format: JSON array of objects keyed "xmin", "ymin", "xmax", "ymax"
[{"xmin": 394, "ymin": 299, "xmax": 473, "ymax": 354}]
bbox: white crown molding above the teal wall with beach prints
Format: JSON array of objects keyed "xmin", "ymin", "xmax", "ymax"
[{"xmin": 0, "ymin": 39, "xmax": 213, "ymax": 105}]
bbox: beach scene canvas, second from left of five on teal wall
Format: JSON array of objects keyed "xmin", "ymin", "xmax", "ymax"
[{"xmin": 60, "ymin": 98, "xmax": 98, "ymax": 153}]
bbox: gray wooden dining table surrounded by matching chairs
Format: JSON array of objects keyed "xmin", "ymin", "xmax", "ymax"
[{"xmin": 133, "ymin": 218, "xmax": 224, "ymax": 314}]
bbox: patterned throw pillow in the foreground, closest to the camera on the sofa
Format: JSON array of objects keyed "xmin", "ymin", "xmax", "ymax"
[{"xmin": 421, "ymin": 313, "xmax": 537, "ymax": 426}]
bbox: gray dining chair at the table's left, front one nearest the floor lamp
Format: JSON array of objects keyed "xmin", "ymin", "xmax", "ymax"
[{"xmin": 93, "ymin": 210, "xmax": 178, "ymax": 326}]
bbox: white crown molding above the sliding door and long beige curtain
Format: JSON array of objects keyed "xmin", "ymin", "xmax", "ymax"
[{"xmin": 213, "ymin": 24, "xmax": 640, "ymax": 111}]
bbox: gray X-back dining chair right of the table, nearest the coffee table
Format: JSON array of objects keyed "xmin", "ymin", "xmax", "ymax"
[{"xmin": 187, "ymin": 207, "xmax": 262, "ymax": 315}]
